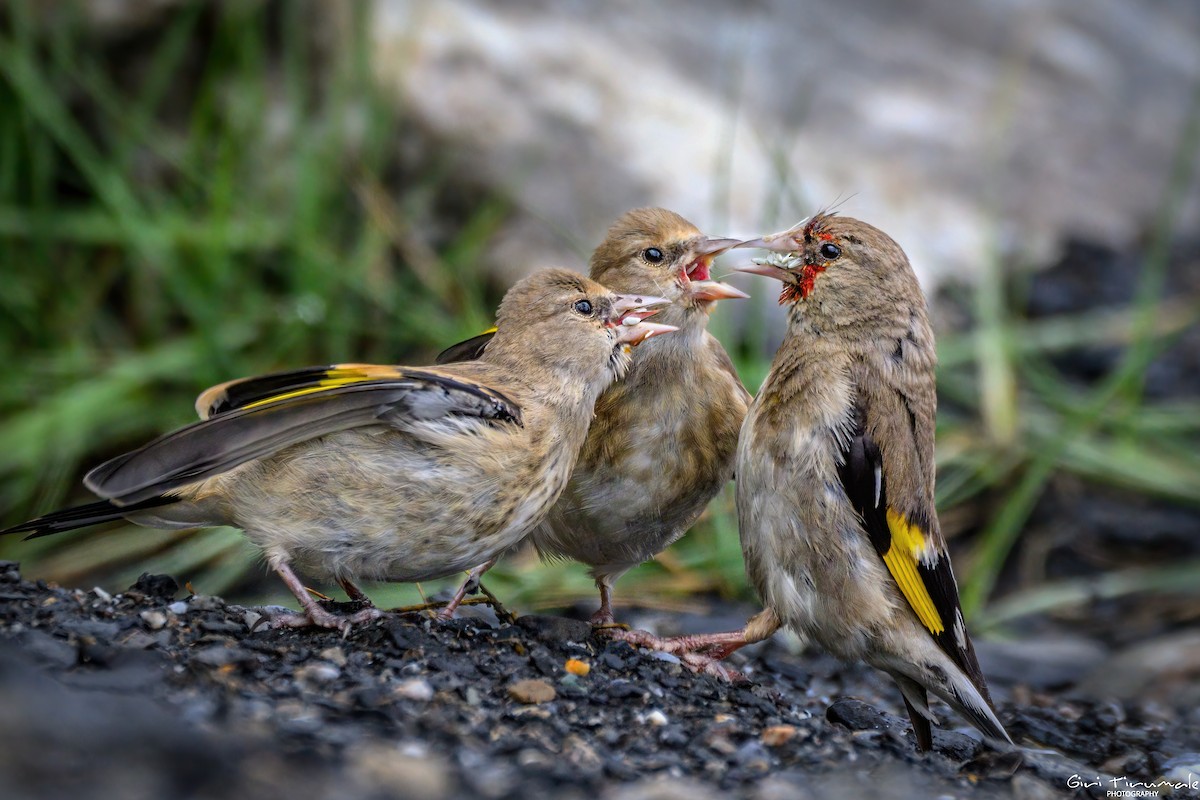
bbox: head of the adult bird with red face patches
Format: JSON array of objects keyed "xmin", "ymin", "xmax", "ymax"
[{"xmin": 733, "ymin": 212, "xmax": 920, "ymax": 308}]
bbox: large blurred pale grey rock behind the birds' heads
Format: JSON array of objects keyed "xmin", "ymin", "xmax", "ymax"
[{"xmin": 371, "ymin": 0, "xmax": 1200, "ymax": 297}]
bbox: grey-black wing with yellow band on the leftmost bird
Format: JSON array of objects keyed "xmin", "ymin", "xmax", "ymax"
[{"xmin": 91, "ymin": 365, "xmax": 521, "ymax": 506}]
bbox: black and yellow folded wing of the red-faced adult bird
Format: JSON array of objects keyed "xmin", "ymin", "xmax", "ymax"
[{"xmin": 839, "ymin": 407, "xmax": 991, "ymax": 703}]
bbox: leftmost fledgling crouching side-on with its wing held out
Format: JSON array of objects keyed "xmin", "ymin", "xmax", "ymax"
[{"xmin": 0, "ymin": 269, "xmax": 676, "ymax": 633}]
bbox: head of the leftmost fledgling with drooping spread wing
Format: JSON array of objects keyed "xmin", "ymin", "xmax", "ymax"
[{"xmin": 484, "ymin": 269, "xmax": 678, "ymax": 389}]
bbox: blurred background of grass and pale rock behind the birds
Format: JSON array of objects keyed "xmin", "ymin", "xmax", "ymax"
[{"xmin": 0, "ymin": 0, "xmax": 1200, "ymax": 663}]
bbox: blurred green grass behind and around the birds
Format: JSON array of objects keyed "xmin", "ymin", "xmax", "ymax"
[{"xmin": 0, "ymin": 2, "xmax": 1200, "ymax": 624}]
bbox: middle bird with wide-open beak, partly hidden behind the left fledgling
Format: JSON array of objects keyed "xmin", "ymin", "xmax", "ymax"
[{"xmin": 439, "ymin": 207, "xmax": 750, "ymax": 627}]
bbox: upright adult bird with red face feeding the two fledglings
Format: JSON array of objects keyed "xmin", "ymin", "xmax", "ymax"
[{"xmin": 619, "ymin": 212, "xmax": 1012, "ymax": 751}]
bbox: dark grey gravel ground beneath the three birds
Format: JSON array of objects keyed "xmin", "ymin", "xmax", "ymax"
[{"xmin": 0, "ymin": 563, "xmax": 1200, "ymax": 800}]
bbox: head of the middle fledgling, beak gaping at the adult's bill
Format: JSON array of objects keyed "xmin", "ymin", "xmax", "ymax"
[{"xmin": 590, "ymin": 209, "xmax": 749, "ymax": 319}]
